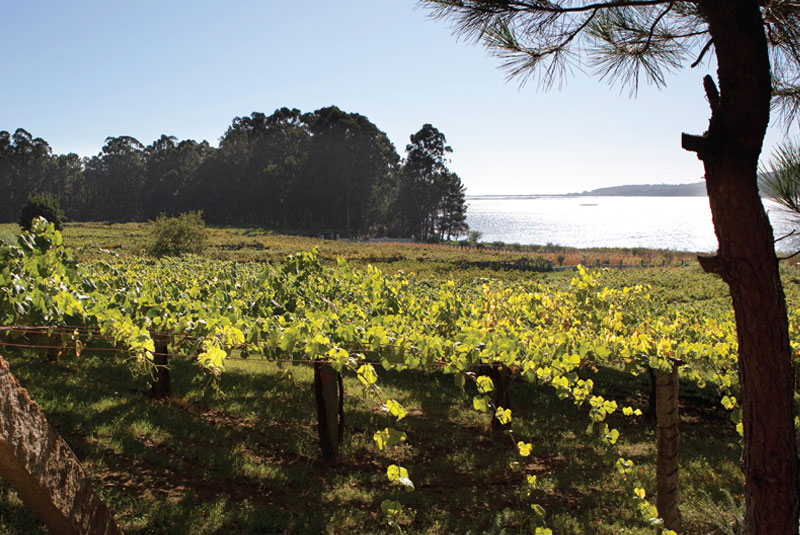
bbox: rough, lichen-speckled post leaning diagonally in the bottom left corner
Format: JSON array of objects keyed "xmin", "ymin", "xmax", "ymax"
[{"xmin": 0, "ymin": 358, "xmax": 122, "ymax": 535}]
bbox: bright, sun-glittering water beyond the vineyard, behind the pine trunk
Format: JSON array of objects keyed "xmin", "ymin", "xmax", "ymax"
[{"xmin": 467, "ymin": 197, "xmax": 800, "ymax": 252}]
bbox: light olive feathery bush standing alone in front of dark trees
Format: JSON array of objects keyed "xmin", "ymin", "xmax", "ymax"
[{"xmin": 145, "ymin": 212, "xmax": 208, "ymax": 257}]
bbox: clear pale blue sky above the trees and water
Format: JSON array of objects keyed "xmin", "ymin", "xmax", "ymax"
[{"xmin": 0, "ymin": 0, "xmax": 783, "ymax": 194}]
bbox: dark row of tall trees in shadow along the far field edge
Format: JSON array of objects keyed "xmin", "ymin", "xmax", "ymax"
[{"xmin": 0, "ymin": 106, "xmax": 468, "ymax": 240}]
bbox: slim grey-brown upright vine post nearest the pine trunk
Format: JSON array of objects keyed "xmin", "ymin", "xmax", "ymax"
[{"xmin": 655, "ymin": 361, "xmax": 681, "ymax": 531}]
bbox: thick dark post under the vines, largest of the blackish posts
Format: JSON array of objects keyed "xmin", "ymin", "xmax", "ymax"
[{"xmin": 314, "ymin": 361, "xmax": 344, "ymax": 462}]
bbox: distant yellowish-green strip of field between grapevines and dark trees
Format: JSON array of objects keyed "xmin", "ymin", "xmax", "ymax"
[{"xmin": 0, "ymin": 222, "xmax": 695, "ymax": 278}]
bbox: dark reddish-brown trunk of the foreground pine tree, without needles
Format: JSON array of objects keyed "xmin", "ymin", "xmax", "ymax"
[{"xmin": 683, "ymin": 0, "xmax": 800, "ymax": 535}]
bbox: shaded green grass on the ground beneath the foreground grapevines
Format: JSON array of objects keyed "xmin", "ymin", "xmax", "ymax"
[{"xmin": 0, "ymin": 353, "xmax": 742, "ymax": 535}]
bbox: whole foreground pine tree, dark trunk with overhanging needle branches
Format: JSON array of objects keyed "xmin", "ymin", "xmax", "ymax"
[{"xmin": 421, "ymin": 0, "xmax": 800, "ymax": 535}]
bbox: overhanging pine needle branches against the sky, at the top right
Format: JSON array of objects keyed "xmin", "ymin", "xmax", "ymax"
[{"xmin": 428, "ymin": 0, "xmax": 800, "ymax": 105}]
